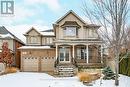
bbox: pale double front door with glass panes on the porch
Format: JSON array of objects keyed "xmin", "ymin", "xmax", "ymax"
[{"xmin": 59, "ymin": 47, "xmax": 70, "ymax": 63}]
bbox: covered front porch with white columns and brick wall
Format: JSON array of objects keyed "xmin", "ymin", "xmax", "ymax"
[{"xmin": 56, "ymin": 44, "xmax": 103, "ymax": 67}]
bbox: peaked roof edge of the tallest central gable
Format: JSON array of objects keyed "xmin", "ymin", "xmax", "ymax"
[{"xmin": 56, "ymin": 10, "xmax": 86, "ymax": 24}]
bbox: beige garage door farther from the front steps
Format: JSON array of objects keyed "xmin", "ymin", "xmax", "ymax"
[{"xmin": 23, "ymin": 57, "xmax": 38, "ymax": 71}]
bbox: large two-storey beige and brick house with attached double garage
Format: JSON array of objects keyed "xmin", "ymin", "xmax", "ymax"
[{"xmin": 19, "ymin": 10, "xmax": 103, "ymax": 75}]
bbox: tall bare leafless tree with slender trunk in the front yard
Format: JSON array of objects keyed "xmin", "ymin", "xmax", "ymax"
[{"xmin": 82, "ymin": 0, "xmax": 129, "ymax": 85}]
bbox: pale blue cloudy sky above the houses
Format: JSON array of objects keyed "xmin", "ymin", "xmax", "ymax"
[{"xmin": 0, "ymin": 0, "xmax": 129, "ymax": 42}]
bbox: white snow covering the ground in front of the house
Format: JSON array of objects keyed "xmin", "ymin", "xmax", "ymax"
[{"xmin": 0, "ymin": 72, "xmax": 130, "ymax": 87}]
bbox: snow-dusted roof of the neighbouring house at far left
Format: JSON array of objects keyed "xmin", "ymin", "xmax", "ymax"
[{"xmin": 0, "ymin": 26, "xmax": 24, "ymax": 44}]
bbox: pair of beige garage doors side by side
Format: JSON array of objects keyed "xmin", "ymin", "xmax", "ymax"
[{"xmin": 23, "ymin": 57, "xmax": 55, "ymax": 72}]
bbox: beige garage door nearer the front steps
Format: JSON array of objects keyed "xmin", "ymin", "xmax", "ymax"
[{"xmin": 41, "ymin": 57, "xmax": 55, "ymax": 71}]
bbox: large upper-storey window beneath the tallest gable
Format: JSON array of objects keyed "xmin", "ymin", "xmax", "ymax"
[{"xmin": 64, "ymin": 26, "xmax": 76, "ymax": 36}]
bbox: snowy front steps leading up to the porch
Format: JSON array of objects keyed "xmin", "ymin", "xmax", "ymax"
[{"xmin": 57, "ymin": 65, "xmax": 75, "ymax": 77}]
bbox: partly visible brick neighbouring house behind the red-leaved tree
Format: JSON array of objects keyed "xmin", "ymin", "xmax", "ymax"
[{"xmin": 0, "ymin": 26, "xmax": 24, "ymax": 68}]
